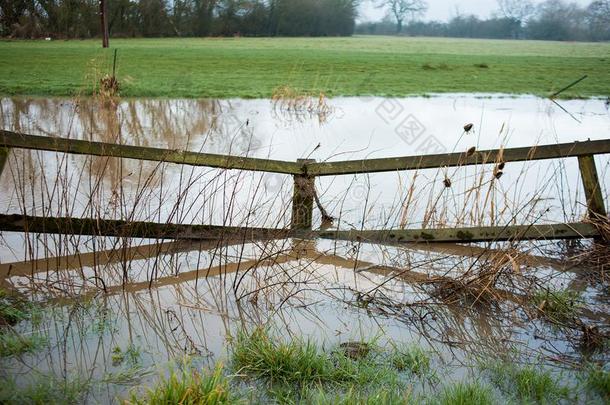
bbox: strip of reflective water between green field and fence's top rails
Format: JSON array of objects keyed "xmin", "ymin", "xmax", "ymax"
[{"xmin": 0, "ymin": 95, "xmax": 610, "ymax": 161}]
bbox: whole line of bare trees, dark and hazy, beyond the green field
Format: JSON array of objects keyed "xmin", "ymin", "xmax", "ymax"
[{"xmin": 0, "ymin": 0, "xmax": 610, "ymax": 41}]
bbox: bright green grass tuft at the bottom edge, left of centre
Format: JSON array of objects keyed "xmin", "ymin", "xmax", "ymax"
[{"xmin": 125, "ymin": 366, "xmax": 237, "ymax": 405}]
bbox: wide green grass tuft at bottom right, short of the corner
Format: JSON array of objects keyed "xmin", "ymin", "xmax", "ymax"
[{"xmin": 487, "ymin": 362, "xmax": 570, "ymax": 403}]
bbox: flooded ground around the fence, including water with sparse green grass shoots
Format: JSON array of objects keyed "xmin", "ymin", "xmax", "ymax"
[{"xmin": 0, "ymin": 95, "xmax": 610, "ymax": 403}]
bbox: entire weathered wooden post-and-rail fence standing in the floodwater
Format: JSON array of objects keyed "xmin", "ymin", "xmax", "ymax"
[{"xmin": 0, "ymin": 131, "xmax": 610, "ymax": 243}]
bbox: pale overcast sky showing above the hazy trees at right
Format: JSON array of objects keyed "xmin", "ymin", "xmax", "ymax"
[{"xmin": 359, "ymin": 0, "xmax": 591, "ymax": 21}]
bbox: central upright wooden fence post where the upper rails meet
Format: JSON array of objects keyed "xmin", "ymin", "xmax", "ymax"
[{"xmin": 290, "ymin": 159, "xmax": 315, "ymax": 230}]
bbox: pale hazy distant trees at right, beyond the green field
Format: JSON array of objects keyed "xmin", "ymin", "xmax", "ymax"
[{"xmin": 356, "ymin": 0, "xmax": 610, "ymax": 41}]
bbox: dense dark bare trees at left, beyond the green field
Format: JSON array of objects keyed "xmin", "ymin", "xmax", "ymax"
[{"xmin": 0, "ymin": 0, "xmax": 358, "ymax": 38}]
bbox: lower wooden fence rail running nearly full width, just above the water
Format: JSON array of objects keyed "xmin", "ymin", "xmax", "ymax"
[{"xmin": 0, "ymin": 214, "xmax": 599, "ymax": 243}]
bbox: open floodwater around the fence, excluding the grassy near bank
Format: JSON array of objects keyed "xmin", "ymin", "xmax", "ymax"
[{"xmin": 0, "ymin": 95, "xmax": 610, "ymax": 402}]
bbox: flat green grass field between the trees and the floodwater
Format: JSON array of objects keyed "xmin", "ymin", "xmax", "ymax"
[{"xmin": 0, "ymin": 37, "xmax": 610, "ymax": 98}]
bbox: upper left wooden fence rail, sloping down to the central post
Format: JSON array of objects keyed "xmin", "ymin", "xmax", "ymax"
[{"xmin": 0, "ymin": 130, "xmax": 302, "ymax": 174}]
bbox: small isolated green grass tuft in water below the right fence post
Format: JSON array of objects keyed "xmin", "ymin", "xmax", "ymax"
[{"xmin": 531, "ymin": 290, "xmax": 583, "ymax": 323}]
